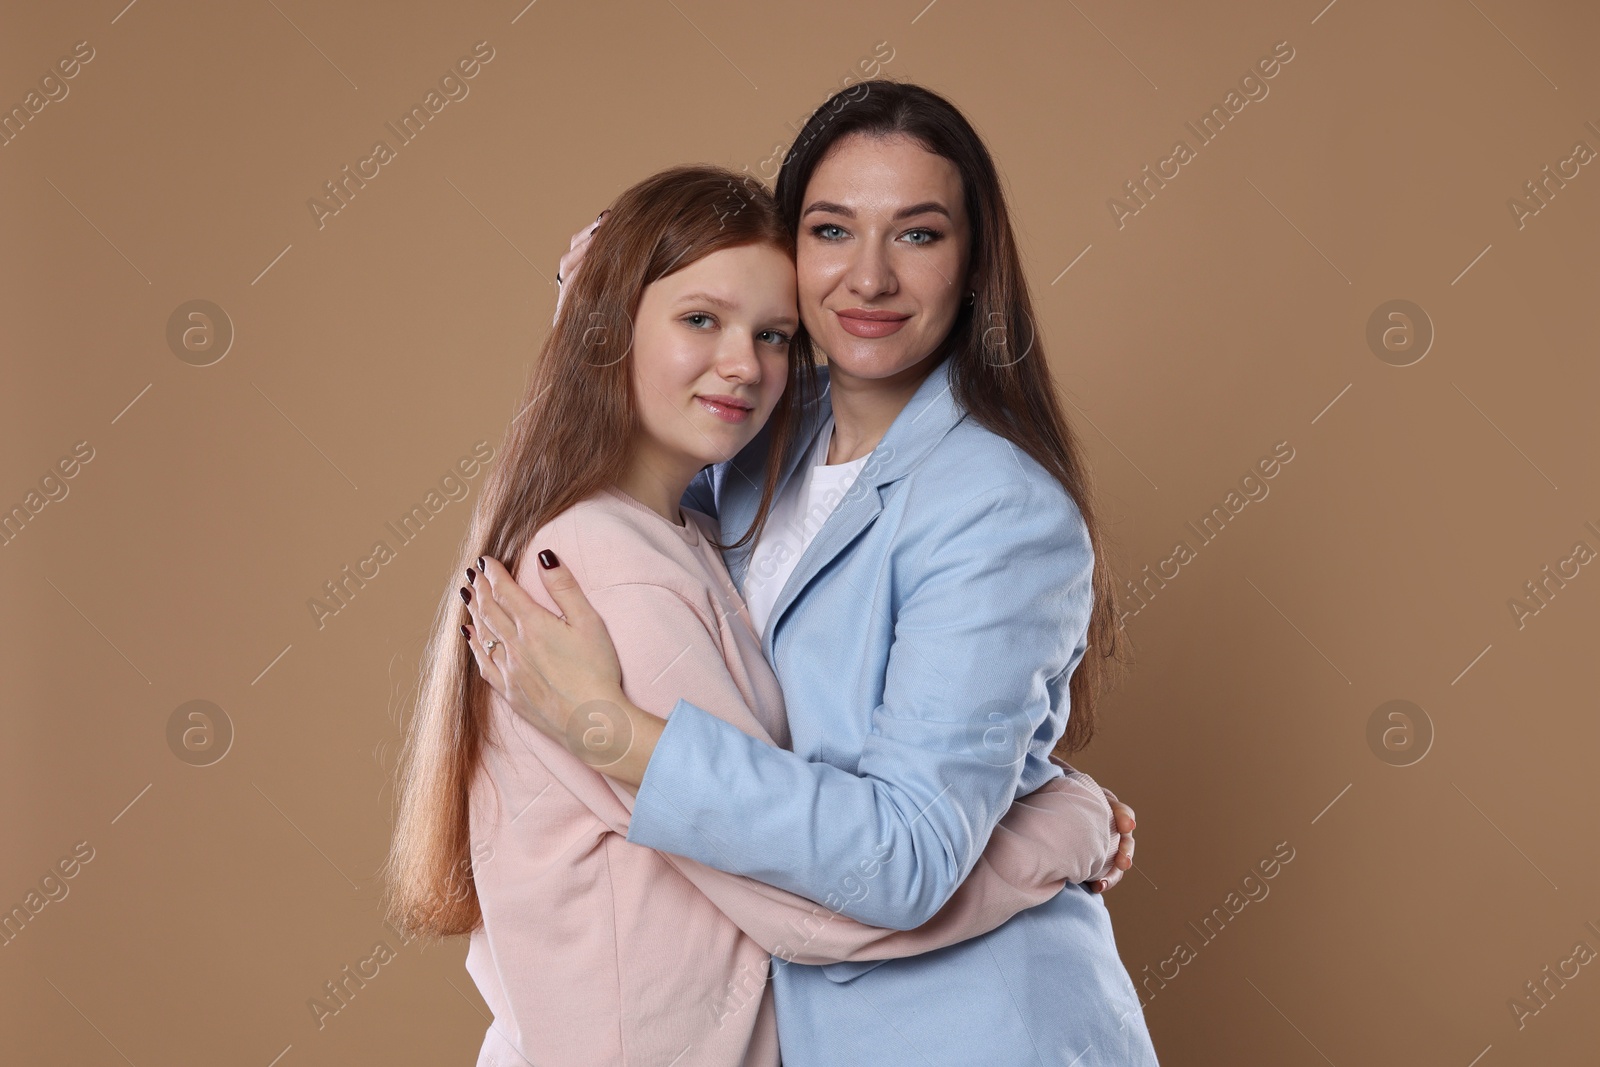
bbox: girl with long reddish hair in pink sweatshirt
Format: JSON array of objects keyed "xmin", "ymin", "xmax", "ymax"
[{"xmin": 389, "ymin": 160, "xmax": 1117, "ymax": 1067}]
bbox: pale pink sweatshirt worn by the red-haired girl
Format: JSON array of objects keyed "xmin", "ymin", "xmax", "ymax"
[{"xmin": 467, "ymin": 490, "xmax": 1117, "ymax": 1067}]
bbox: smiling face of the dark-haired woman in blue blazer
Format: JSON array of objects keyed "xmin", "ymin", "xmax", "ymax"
[{"xmin": 795, "ymin": 134, "xmax": 971, "ymax": 379}]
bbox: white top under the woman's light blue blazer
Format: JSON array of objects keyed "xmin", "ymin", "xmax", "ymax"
[{"xmin": 744, "ymin": 416, "xmax": 872, "ymax": 637}]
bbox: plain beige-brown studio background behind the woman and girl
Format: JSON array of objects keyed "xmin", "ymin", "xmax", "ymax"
[{"xmin": 0, "ymin": 0, "xmax": 1600, "ymax": 1067}]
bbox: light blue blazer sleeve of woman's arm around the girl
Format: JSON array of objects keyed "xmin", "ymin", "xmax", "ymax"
[{"xmin": 627, "ymin": 480, "xmax": 1094, "ymax": 929}]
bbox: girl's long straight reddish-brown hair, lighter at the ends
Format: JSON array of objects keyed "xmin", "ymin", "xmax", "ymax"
[{"xmin": 384, "ymin": 166, "xmax": 816, "ymax": 937}]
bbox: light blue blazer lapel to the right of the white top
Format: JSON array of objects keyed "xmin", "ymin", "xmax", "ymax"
[{"xmin": 758, "ymin": 357, "xmax": 966, "ymax": 662}]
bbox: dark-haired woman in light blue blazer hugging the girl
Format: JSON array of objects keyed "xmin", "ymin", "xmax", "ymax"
[{"xmin": 470, "ymin": 82, "xmax": 1155, "ymax": 1067}]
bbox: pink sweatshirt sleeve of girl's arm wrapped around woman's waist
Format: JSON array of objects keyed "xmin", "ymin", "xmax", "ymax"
[{"xmin": 534, "ymin": 566, "xmax": 1117, "ymax": 965}]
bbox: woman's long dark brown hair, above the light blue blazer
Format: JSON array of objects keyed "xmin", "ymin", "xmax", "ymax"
[{"xmin": 778, "ymin": 80, "xmax": 1128, "ymax": 755}]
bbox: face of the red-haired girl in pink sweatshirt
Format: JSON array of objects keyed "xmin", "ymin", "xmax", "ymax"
[{"xmin": 632, "ymin": 245, "xmax": 800, "ymax": 485}]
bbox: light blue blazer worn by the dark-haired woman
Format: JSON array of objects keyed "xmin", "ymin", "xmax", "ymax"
[{"xmin": 627, "ymin": 360, "xmax": 1157, "ymax": 1067}]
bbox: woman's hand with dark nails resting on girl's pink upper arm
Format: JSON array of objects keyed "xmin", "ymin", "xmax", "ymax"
[{"xmin": 462, "ymin": 550, "xmax": 629, "ymax": 751}]
